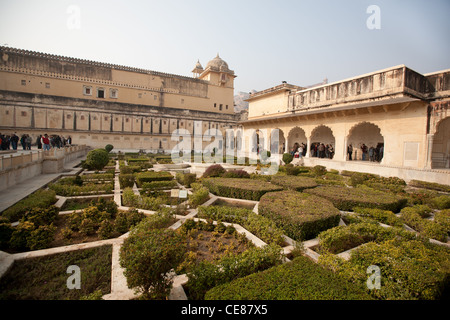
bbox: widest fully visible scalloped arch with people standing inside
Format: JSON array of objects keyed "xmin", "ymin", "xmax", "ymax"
[{"xmin": 347, "ymin": 121, "xmax": 384, "ymax": 162}]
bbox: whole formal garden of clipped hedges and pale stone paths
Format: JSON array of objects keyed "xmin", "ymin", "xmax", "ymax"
[{"xmin": 0, "ymin": 152, "xmax": 450, "ymax": 300}]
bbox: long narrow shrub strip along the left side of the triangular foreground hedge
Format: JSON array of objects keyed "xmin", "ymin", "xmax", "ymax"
[{"xmin": 186, "ymin": 245, "xmax": 282, "ymax": 300}]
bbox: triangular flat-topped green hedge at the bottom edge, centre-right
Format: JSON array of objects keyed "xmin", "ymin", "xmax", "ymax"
[{"xmin": 205, "ymin": 256, "xmax": 372, "ymax": 300}]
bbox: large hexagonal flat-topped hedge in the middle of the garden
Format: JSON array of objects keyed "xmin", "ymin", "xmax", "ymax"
[{"xmin": 258, "ymin": 191, "xmax": 340, "ymax": 240}]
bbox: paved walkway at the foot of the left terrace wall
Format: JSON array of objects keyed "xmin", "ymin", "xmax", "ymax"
[{"xmin": 0, "ymin": 156, "xmax": 84, "ymax": 212}]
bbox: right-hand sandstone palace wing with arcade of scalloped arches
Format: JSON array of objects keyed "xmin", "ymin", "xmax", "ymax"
[{"xmin": 242, "ymin": 65, "xmax": 450, "ymax": 184}]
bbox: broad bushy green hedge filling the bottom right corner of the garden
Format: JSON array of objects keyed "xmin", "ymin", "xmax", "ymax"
[{"xmin": 319, "ymin": 240, "xmax": 450, "ymax": 300}]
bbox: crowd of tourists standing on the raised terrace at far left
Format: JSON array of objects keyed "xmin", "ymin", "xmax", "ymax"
[{"xmin": 0, "ymin": 133, "xmax": 72, "ymax": 150}]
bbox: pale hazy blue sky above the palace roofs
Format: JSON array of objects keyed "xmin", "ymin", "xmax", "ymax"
[{"xmin": 0, "ymin": 0, "xmax": 450, "ymax": 92}]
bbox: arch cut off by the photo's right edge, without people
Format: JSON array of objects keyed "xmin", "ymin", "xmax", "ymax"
[{"xmin": 431, "ymin": 117, "xmax": 450, "ymax": 169}]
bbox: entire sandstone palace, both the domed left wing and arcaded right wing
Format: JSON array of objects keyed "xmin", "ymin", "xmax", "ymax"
[{"xmin": 0, "ymin": 47, "xmax": 450, "ymax": 184}]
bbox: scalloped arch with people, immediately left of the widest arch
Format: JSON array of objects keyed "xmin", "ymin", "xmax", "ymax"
[{"xmin": 309, "ymin": 125, "xmax": 336, "ymax": 159}]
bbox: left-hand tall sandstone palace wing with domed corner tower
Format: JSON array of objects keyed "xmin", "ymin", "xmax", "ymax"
[{"xmin": 0, "ymin": 47, "xmax": 243, "ymax": 151}]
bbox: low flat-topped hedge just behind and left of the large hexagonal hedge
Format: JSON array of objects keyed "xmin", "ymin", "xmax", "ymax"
[{"xmin": 202, "ymin": 178, "xmax": 282, "ymax": 201}]
